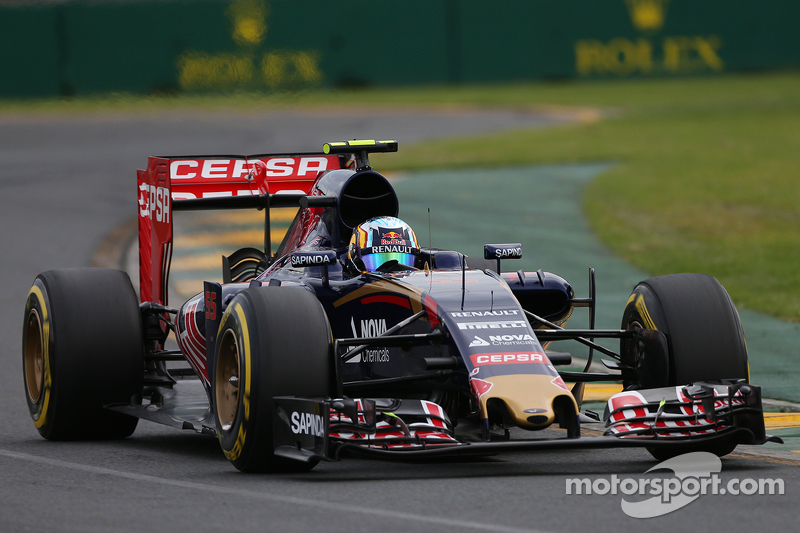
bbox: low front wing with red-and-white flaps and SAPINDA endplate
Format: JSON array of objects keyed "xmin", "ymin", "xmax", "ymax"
[{"xmin": 273, "ymin": 383, "xmax": 781, "ymax": 461}]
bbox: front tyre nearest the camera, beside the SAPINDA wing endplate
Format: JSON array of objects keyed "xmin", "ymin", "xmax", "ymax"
[{"xmin": 211, "ymin": 287, "xmax": 333, "ymax": 472}]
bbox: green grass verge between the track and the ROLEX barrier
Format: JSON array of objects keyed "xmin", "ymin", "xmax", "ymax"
[{"xmin": 6, "ymin": 73, "xmax": 800, "ymax": 321}]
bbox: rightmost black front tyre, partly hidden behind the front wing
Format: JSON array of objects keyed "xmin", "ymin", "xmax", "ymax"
[{"xmin": 620, "ymin": 274, "xmax": 749, "ymax": 460}]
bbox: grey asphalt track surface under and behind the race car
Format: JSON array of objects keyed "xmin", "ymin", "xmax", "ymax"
[{"xmin": 0, "ymin": 112, "xmax": 800, "ymax": 532}]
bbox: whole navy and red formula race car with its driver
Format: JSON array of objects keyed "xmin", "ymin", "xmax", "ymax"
[{"xmin": 23, "ymin": 141, "xmax": 779, "ymax": 471}]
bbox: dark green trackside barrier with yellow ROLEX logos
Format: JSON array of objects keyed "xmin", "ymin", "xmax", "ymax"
[{"xmin": 0, "ymin": 0, "xmax": 800, "ymax": 97}]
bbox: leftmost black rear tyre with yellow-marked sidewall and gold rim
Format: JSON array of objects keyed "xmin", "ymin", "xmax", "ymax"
[{"xmin": 22, "ymin": 268, "xmax": 144, "ymax": 440}]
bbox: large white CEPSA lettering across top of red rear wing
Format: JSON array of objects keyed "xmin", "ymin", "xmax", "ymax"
[{"xmin": 169, "ymin": 157, "xmax": 328, "ymax": 181}]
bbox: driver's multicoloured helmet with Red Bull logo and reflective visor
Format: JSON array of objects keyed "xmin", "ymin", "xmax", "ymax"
[{"xmin": 347, "ymin": 217, "xmax": 419, "ymax": 272}]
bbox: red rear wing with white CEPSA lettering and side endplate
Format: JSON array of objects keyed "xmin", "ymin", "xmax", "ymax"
[{"xmin": 137, "ymin": 153, "xmax": 346, "ymax": 305}]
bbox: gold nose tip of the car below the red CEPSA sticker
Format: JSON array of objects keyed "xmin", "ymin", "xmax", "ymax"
[{"xmin": 472, "ymin": 374, "xmax": 578, "ymax": 429}]
